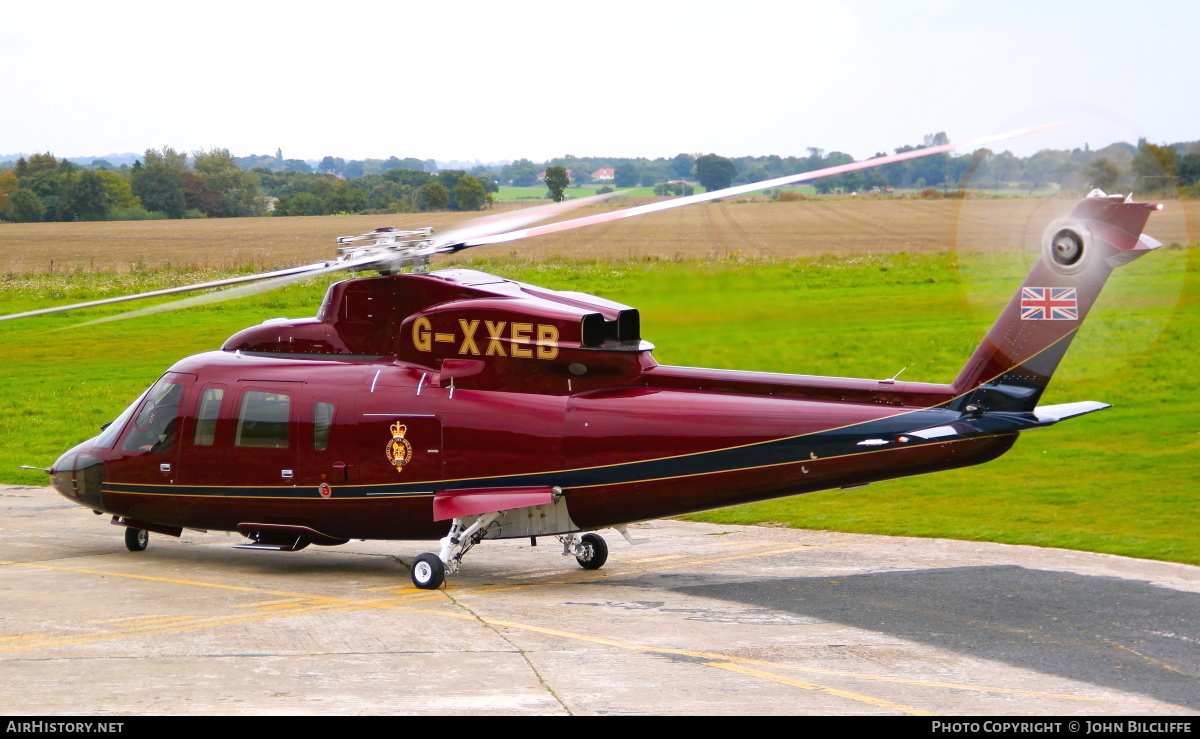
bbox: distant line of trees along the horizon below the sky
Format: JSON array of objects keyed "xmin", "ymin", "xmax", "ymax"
[{"xmin": 0, "ymin": 132, "xmax": 1200, "ymax": 222}]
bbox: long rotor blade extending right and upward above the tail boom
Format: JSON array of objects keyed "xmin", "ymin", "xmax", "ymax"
[{"xmin": 452, "ymin": 122, "xmax": 1063, "ymax": 251}]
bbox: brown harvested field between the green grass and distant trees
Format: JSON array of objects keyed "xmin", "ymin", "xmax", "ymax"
[{"xmin": 0, "ymin": 198, "xmax": 1200, "ymax": 274}]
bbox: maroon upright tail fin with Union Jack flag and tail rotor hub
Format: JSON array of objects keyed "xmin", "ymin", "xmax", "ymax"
[{"xmin": 952, "ymin": 190, "xmax": 1163, "ymax": 413}]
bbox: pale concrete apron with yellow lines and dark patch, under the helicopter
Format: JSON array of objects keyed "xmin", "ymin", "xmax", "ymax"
[{"xmin": 0, "ymin": 487, "xmax": 1200, "ymax": 716}]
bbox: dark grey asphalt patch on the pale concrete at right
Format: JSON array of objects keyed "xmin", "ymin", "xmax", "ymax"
[{"xmin": 572, "ymin": 565, "xmax": 1200, "ymax": 710}]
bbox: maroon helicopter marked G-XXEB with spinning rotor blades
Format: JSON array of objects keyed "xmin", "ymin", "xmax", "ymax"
[{"xmin": 7, "ymin": 128, "xmax": 1162, "ymax": 589}]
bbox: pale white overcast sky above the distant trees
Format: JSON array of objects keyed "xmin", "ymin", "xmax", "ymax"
[{"xmin": 0, "ymin": 0, "xmax": 1200, "ymax": 161}]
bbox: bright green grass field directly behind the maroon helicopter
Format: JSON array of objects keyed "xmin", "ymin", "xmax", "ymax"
[{"xmin": 0, "ymin": 245, "xmax": 1200, "ymax": 564}]
